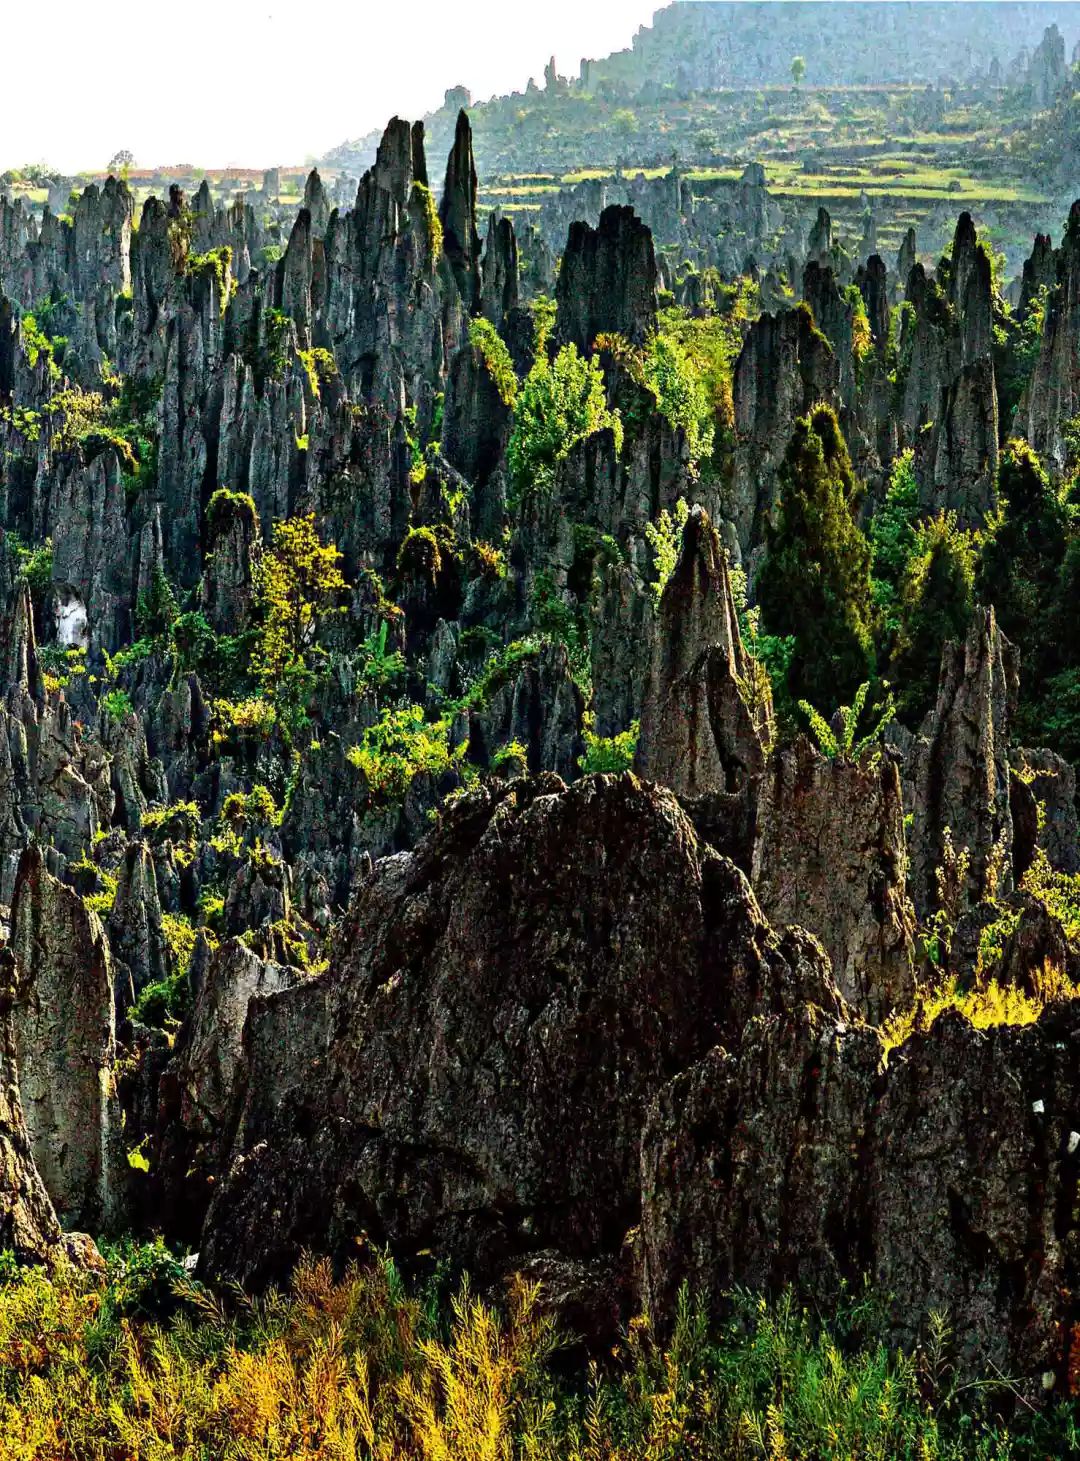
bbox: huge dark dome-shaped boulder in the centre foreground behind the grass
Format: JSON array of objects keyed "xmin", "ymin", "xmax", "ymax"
[{"xmin": 202, "ymin": 776, "xmax": 821, "ymax": 1281}]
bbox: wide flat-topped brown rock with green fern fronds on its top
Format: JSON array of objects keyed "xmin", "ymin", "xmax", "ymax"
[{"xmin": 751, "ymin": 738, "xmax": 915, "ymax": 1020}]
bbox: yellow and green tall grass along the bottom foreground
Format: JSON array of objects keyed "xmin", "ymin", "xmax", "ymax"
[{"xmin": 0, "ymin": 1245, "xmax": 1076, "ymax": 1461}]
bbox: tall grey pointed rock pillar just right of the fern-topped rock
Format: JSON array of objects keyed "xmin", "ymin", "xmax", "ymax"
[{"xmin": 910, "ymin": 609, "xmax": 1019, "ymax": 916}]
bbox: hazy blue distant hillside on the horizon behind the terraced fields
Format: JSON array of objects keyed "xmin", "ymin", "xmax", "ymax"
[{"xmin": 322, "ymin": 0, "xmax": 1080, "ymax": 174}]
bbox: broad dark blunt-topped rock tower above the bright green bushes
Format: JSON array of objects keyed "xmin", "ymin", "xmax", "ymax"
[{"xmin": 555, "ymin": 206, "xmax": 656, "ymax": 354}]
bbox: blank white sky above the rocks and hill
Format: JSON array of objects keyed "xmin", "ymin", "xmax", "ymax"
[{"xmin": 0, "ymin": 0, "xmax": 663, "ymax": 171}]
